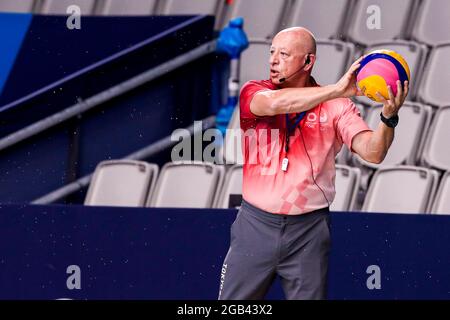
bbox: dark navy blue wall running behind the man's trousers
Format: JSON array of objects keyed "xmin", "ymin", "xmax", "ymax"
[{"xmin": 0, "ymin": 205, "xmax": 450, "ymax": 299}]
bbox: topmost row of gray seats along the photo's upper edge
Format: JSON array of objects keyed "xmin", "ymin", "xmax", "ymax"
[{"xmin": 0, "ymin": 0, "xmax": 450, "ymax": 46}]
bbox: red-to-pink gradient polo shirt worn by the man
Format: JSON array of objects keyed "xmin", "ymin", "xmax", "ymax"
[{"xmin": 239, "ymin": 80, "xmax": 370, "ymax": 215}]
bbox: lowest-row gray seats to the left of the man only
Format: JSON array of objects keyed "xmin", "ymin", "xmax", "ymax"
[{"xmin": 85, "ymin": 160, "xmax": 242, "ymax": 208}]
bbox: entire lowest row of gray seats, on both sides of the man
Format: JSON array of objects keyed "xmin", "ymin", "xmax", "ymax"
[{"xmin": 85, "ymin": 160, "xmax": 450, "ymax": 214}]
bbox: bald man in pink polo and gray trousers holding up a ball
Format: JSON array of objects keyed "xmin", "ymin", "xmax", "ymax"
[{"xmin": 219, "ymin": 27, "xmax": 408, "ymax": 299}]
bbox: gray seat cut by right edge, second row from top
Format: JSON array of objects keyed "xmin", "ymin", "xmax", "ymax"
[{"xmin": 417, "ymin": 43, "xmax": 450, "ymax": 107}]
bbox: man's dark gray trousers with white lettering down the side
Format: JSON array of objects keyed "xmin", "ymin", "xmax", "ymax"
[{"xmin": 219, "ymin": 200, "xmax": 330, "ymax": 300}]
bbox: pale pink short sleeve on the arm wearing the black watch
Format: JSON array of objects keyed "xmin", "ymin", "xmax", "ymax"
[{"xmin": 337, "ymin": 100, "xmax": 372, "ymax": 152}]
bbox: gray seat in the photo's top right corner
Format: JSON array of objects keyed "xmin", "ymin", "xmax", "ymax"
[{"xmin": 412, "ymin": 0, "xmax": 450, "ymax": 46}]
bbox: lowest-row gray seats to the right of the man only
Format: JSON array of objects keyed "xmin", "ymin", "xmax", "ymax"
[{"xmin": 331, "ymin": 165, "xmax": 450, "ymax": 214}]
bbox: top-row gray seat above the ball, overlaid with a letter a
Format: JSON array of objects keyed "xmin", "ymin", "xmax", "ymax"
[{"xmin": 347, "ymin": 0, "xmax": 417, "ymax": 46}]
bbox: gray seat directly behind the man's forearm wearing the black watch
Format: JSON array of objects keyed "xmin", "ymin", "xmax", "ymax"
[{"xmin": 355, "ymin": 102, "xmax": 432, "ymax": 168}]
